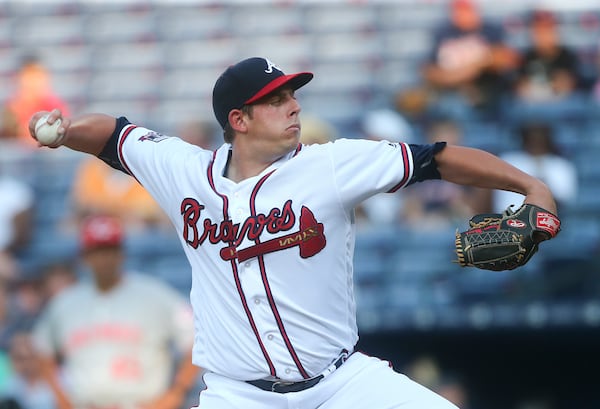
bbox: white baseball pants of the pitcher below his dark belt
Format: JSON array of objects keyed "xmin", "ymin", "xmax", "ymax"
[{"xmin": 194, "ymin": 352, "xmax": 458, "ymax": 409}]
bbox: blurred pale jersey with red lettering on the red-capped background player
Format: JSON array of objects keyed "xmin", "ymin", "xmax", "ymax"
[{"xmin": 33, "ymin": 274, "xmax": 193, "ymax": 408}]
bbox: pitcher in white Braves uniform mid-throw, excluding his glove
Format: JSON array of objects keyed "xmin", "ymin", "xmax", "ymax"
[{"xmin": 30, "ymin": 57, "xmax": 556, "ymax": 409}]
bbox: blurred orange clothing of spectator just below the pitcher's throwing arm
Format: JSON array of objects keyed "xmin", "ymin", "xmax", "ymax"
[{"xmin": 70, "ymin": 157, "xmax": 170, "ymax": 232}]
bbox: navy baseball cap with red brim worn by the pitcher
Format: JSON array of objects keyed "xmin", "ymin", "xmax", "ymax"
[{"xmin": 213, "ymin": 57, "xmax": 313, "ymax": 129}]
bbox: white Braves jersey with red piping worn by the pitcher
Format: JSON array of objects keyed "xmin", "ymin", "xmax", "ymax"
[{"xmin": 111, "ymin": 119, "xmax": 431, "ymax": 380}]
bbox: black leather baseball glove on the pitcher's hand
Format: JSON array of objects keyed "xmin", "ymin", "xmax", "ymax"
[{"xmin": 456, "ymin": 204, "xmax": 560, "ymax": 271}]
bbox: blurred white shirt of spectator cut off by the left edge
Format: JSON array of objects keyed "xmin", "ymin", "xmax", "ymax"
[{"xmin": 0, "ymin": 173, "xmax": 35, "ymax": 254}]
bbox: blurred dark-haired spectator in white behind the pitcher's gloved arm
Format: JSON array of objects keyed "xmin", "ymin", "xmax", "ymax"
[{"xmin": 492, "ymin": 123, "xmax": 579, "ymax": 212}]
